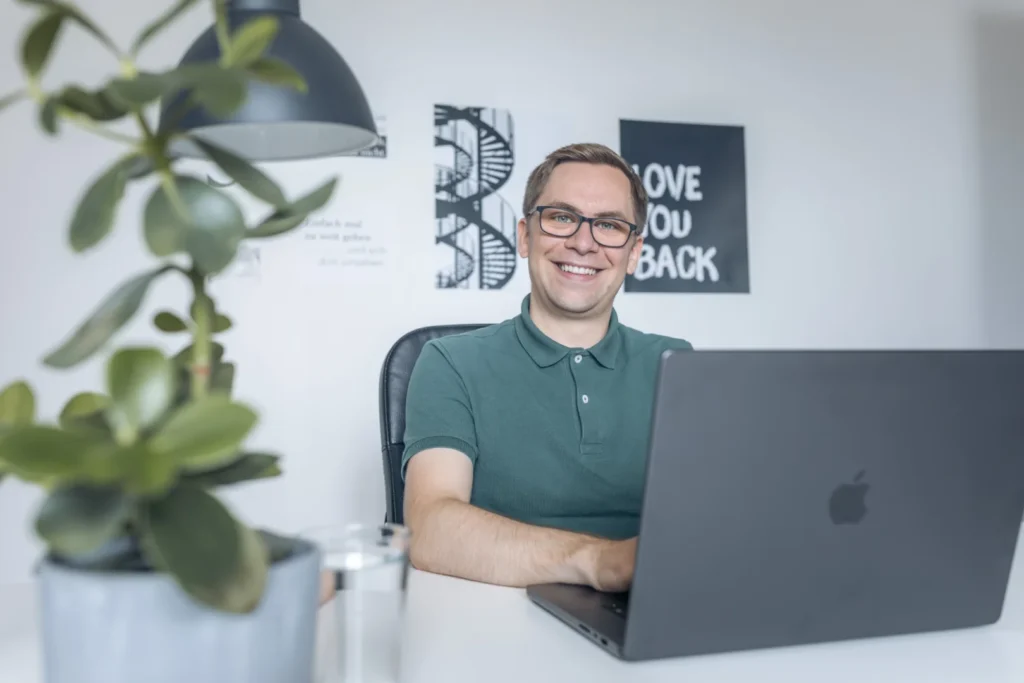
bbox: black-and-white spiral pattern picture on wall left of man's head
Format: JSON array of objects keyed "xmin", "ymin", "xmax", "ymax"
[{"xmin": 434, "ymin": 104, "xmax": 518, "ymax": 290}]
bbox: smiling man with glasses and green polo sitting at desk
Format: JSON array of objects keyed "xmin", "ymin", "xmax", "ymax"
[{"xmin": 403, "ymin": 144, "xmax": 692, "ymax": 591}]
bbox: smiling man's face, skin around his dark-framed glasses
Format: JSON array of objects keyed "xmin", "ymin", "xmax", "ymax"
[{"xmin": 518, "ymin": 162, "xmax": 642, "ymax": 318}]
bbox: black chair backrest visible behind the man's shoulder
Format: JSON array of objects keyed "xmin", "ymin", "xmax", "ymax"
[{"xmin": 380, "ymin": 325, "xmax": 484, "ymax": 524}]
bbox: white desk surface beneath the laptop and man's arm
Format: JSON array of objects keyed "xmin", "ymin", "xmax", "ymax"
[{"xmin": 6, "ymin": 567, "xmax": 1024, "ymax": 683}]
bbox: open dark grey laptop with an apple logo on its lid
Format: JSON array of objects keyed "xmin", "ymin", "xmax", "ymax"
[{"xmin": 527, "ymin": 350, "xmax": 1024, "ymax": 660}]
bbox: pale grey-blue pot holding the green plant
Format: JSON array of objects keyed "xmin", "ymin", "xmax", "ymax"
[{"xmin": 39, "ymin": 541, "xmax": 321, "ymax": 683}]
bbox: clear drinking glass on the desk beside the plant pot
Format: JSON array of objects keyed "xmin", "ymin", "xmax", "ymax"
[{"xmin": 304, "ymin": 524, "xmax": 409, "ymax": 683}]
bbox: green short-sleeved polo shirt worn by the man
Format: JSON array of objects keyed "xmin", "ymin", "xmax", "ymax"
[{"xmin": 402, "ymin": 295, "xmax": 692, "ymax": 539}]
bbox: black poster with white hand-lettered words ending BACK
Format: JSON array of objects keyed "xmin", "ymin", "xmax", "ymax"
[{"xmin": 618, "ymin": 120, "xmax": 751, "ymax": 294}]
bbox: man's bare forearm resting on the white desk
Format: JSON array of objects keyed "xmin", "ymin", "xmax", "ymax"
[{"xmin": 412, "ymin": 499, "xmax": 599, "ymax": 588}]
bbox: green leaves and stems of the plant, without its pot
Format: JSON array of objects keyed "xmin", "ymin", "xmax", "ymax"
[{"xmin": 0, "ymin": 0, "xmax": 337, "ymax": 613}]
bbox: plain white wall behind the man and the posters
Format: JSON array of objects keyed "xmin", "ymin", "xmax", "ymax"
[{"xmin": 0, "ymin": 0, "xmax": 1024, "ymax": 582}]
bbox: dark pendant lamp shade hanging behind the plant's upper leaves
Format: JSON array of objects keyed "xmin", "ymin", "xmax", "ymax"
[{"xmin": 161, "ymin": 0, "xmax": 378, "ymax": 161}]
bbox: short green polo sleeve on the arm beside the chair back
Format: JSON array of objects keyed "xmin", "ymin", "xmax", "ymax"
[{"xmin": 401, "ymin": 340, "xmax": 477, "ymax": 479}]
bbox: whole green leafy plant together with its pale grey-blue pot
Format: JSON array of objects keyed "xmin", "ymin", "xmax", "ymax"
[{"xmin": 0, "ymin": 0, "xmax": 336, "ymax": 683}]
